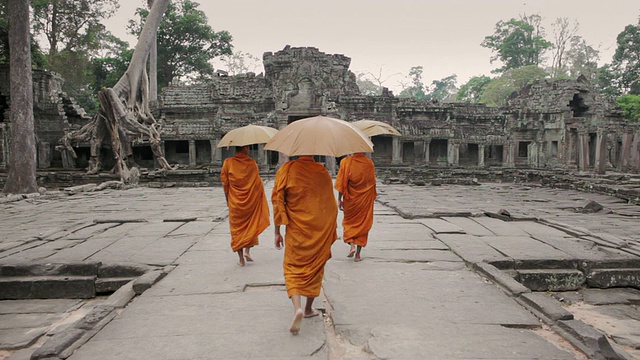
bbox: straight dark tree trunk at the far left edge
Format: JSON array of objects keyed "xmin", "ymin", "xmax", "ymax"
[{"xmin": 3, "ymin": 0, "xmax": 38, "ymax": 194}]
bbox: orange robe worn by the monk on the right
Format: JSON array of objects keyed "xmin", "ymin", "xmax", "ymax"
[{"xmin": 335, "ymin": 153, "xmax": 378, "ymax": 246}]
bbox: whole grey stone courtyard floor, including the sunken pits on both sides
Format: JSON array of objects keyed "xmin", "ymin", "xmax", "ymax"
[{"xmin": 0, "ymin": 179, "xmax": 640, "ymax": 360}]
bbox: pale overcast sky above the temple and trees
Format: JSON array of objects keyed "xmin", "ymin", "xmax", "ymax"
[{"xmin": 106, "ymin": 0, "xmax": 640, "ymax": 94}]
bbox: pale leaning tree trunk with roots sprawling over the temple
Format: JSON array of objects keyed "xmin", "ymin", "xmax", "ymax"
[{"xmin": 57, "ymin": 0, "xmax": 171, "ymax": 183}]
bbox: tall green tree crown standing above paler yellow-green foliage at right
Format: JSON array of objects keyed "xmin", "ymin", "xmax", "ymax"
[{"xmin": 480, "ymin": 15, "xmax": 552, "ymax": 73}]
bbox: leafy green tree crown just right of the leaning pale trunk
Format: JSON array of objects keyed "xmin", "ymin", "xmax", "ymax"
[{"xmin": 128, "ymin": 0, "xmax": 233, "ymax": 88}]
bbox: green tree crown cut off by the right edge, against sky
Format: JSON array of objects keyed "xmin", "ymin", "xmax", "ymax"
[{"xmin": 611, "ymin": 19, "xmax": 640, "ymax": 95}]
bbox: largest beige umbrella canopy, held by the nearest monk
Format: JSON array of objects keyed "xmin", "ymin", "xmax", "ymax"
[{"xmin": 264, "ymin": 116, "xmax": 373, "ymax": 156}]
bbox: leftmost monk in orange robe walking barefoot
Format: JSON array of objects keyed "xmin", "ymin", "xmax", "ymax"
[{"xmin": 220, "ymin": 146, "xmax": 269, "ymax": 266}]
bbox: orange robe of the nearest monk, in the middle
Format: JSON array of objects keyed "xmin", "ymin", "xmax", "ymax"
[{"xmin": 271, "ymin": 156, "xmax": 338, "ymax": 297}]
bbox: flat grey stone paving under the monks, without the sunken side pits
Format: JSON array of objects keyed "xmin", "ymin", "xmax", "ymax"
[{"xmin": 0, "ymin": 183, "xmax": 640, "ymax": 359}]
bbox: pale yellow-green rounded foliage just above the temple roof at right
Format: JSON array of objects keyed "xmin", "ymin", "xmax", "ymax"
[{"xmin": 480, "ymin": 65, "xmax": 548, "ymax": 106}]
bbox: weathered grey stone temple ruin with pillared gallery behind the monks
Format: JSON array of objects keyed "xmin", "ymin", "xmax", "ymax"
[{"xmin": 0, "ymin": 46, "xmax": 640, "ymax": 179}]
